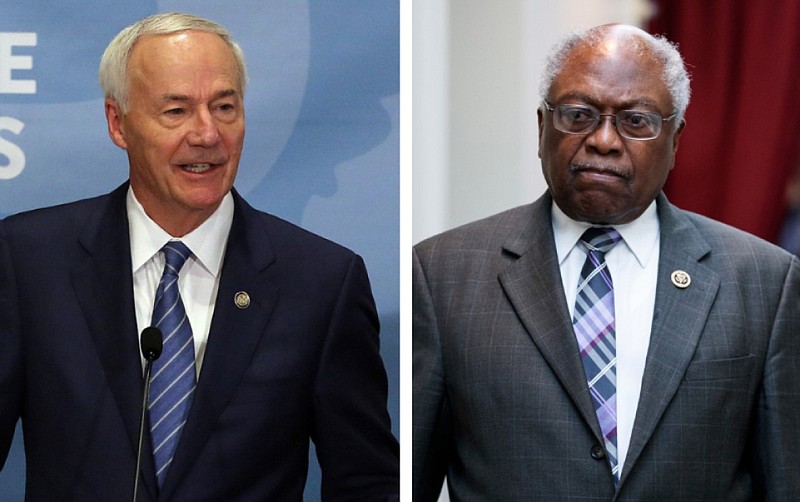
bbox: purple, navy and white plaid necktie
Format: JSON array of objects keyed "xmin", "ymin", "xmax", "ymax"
[{"xmin": 572, "ymin": 227, "xmax": 621, "ymax": 483}]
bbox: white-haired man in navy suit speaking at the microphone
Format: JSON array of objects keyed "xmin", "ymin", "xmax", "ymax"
[{"xmin": 0, "ymin": 13, "xmax": 399, "ymax": 502}]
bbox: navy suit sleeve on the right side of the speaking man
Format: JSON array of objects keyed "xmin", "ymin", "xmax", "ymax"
[{"xmin": 313, "ymin": 256, "xmax": 400, "ymax": 501}]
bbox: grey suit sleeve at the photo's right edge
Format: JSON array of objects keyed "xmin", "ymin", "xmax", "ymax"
[{"xmin": 753, "ymin": 258, "xmax": 800, "ymax": 501}]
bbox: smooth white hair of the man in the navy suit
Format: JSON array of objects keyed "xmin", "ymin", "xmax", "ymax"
[{"xmin": 98, "ymin": 12, "xmax": 247, "ymax": 113}]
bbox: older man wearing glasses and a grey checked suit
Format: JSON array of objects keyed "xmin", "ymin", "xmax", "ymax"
[{"xmin": 413, "ymin": 25, "xmax": 800, "ymax": 502}]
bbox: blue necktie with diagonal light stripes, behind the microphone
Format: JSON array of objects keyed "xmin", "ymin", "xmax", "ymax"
[{"xmin": 149, "ymin": 241, "xmax": 196, "ymax": 486}]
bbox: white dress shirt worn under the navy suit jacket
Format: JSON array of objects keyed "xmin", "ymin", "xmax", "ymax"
[{"xmin": 127, "ymin": 188, "xmax": 233, "ymax": 376}]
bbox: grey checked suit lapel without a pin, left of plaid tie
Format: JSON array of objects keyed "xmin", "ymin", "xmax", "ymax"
[{"xmin": 500, "ymin": 194, "xmax": 602, "ymax": 441}]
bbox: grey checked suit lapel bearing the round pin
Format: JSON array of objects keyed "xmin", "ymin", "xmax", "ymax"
[{"xmin": 620, "ymin": 195, "xmax": 720, "ymax": 486}]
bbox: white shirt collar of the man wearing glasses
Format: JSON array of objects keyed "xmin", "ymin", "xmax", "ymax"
[{"xmin": 552, "ymin": 200, "xmax": 660, "ymax": 268}]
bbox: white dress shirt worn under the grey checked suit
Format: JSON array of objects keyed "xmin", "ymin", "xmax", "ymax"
[{"xmin": 553, "ymin": 201, "xmax": 660, "ymax": 474}]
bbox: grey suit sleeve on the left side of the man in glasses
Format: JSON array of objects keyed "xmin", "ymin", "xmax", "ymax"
[{"xmin": 412, "ymin": 250, "xmax": 450, "ymax": 502}]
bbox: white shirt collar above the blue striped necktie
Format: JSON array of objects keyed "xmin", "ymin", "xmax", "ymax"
[{"xmin": 126, "ymin": 187, "xmax": 233, "ymax": 277}]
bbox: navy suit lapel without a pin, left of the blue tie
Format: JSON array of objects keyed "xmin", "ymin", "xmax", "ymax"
[{"xmin": 71, "ymin": 183, "xmax": 160, "ymax": 494}]
